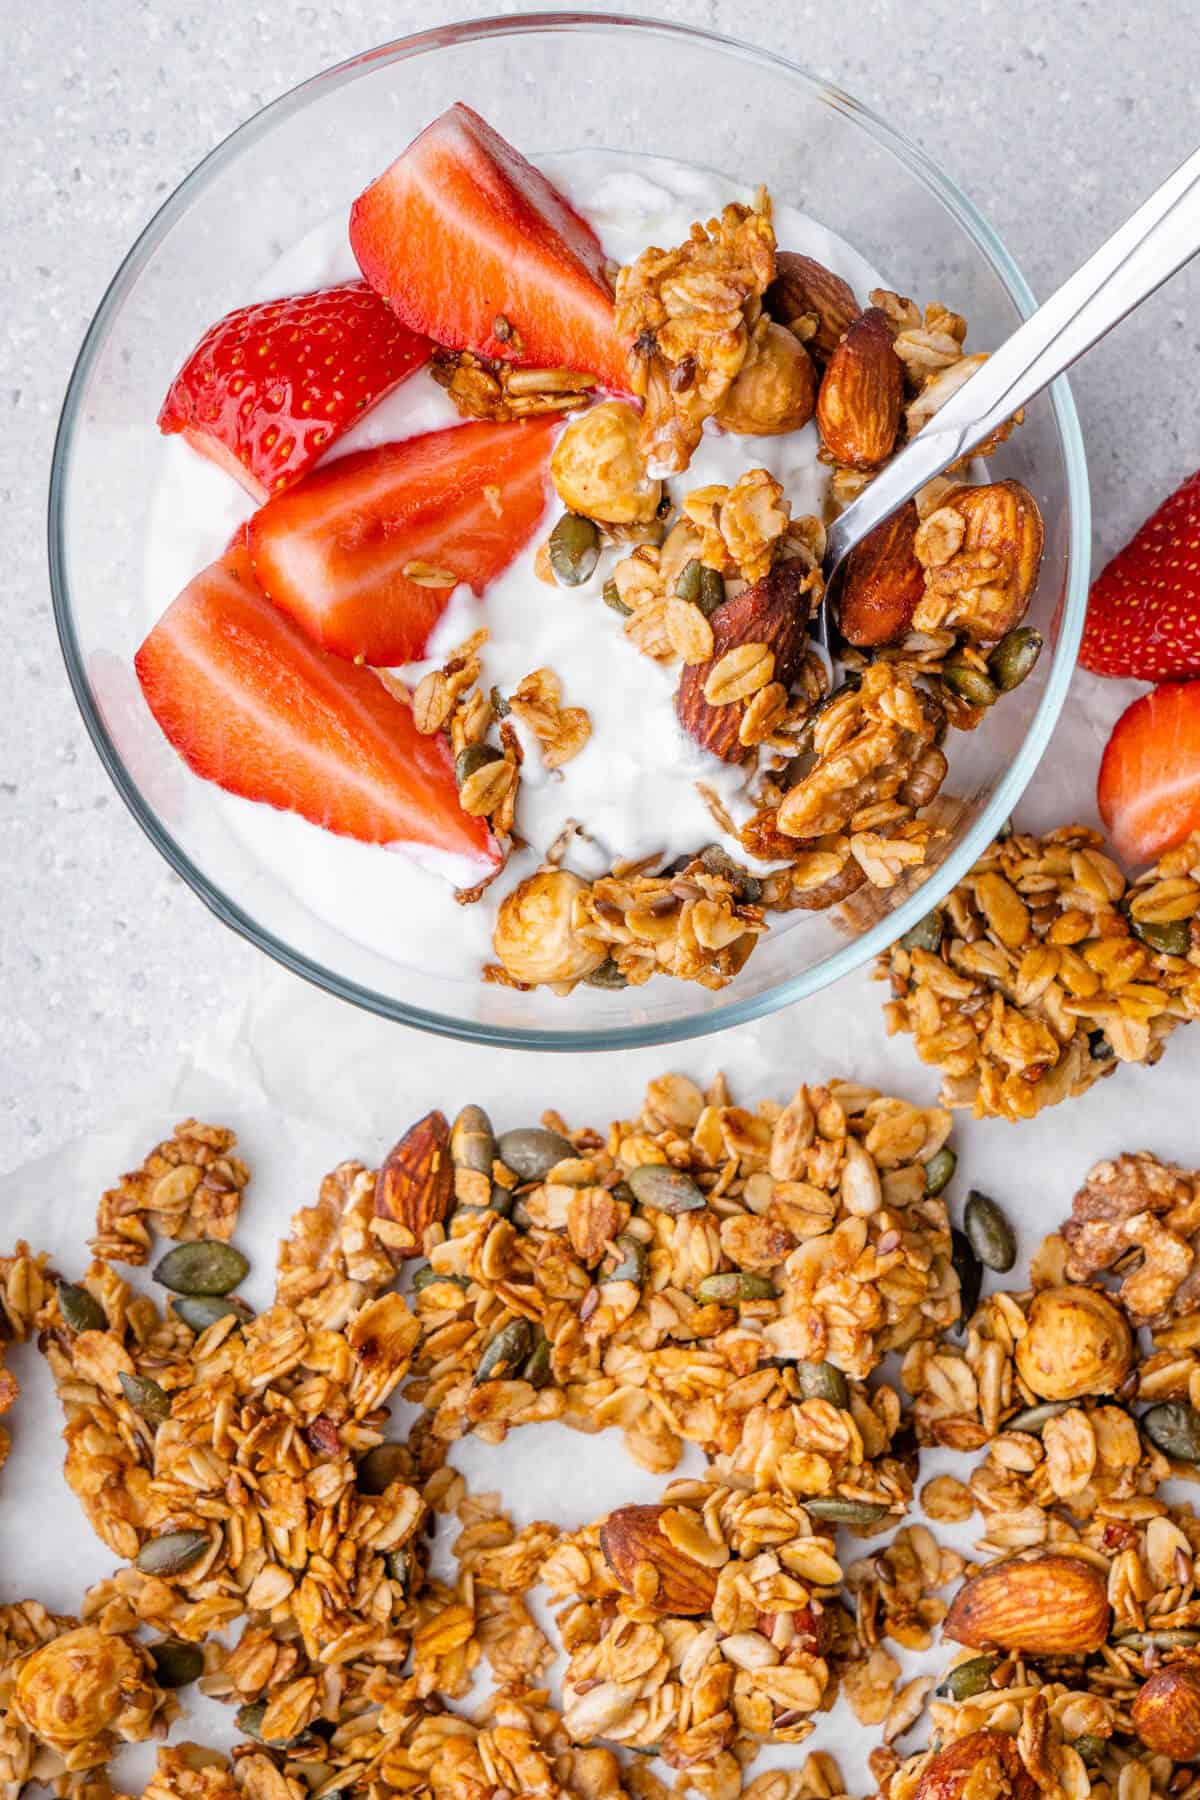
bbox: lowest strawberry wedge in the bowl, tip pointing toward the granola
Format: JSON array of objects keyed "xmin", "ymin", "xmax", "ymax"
[{"xmin": 135, "ymin": 547, "xmax": 498, "ymax": 869}]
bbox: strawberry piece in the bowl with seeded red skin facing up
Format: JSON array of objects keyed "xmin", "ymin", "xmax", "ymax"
[{"xmin": 158, "ymin": 281, "xmax": 434, "ymax": 500}]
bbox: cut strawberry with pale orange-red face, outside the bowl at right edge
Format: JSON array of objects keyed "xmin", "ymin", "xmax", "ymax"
[{"xmin": 1096, "ymin": 680, "xmax": 1200, "ymax": 866}]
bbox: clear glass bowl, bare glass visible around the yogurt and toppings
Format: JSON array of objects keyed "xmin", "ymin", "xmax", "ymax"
[{"xmin": 50, "ymin": 13, "xmax": 1090, "ymax": 1049}]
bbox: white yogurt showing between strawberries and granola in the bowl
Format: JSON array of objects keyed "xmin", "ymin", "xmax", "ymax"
[{"xmin": 146, "ymin": 151, "xmax": 880, "ymax": 977}]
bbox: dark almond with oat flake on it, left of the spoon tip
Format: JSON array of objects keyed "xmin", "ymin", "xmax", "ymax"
[{"xmin": 675, "ymin": 558, "xmax": 810, "ymax": 763}]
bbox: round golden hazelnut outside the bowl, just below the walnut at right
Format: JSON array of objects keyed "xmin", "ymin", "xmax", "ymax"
[{"xmin": 1015, "ymin": 1287, "xmax": 1133, "ymax": 1400}]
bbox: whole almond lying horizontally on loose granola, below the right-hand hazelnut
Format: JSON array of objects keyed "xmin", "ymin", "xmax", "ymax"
[{"xmin": 941, "ymin": 1552, "xmax": 1110, "ymax": 1656}]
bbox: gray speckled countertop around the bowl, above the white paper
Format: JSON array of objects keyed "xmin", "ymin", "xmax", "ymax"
[{"xmin": 0, "ymin": 0, "xmax": 1200, "ymax": 1168}]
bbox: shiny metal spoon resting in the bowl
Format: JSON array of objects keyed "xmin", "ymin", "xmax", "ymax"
[{"xmin": 813, "ymin": 149, "xmax": 1200, "ymax": 655}]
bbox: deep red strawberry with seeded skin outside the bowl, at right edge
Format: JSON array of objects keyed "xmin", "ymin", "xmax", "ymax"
[{"xmin": 1079, "ymin": 470, "xmax": 1200, "ymax": 680}]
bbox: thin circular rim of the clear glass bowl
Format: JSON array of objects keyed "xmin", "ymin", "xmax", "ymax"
[{"xmin": 47, "ymin": 13, "xmax": 1092, "ymax": 1051}]
